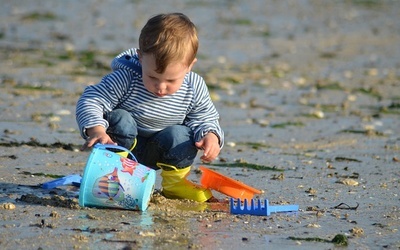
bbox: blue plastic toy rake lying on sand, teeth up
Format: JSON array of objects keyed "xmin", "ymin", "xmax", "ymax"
[{"xmin": 230, "ymin": 198, "xmax": 299, "ymax": 216}]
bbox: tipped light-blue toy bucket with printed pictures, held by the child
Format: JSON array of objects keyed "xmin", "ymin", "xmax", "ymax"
[{"xmin": 79, "ymin": 144, "xmax": 156, "ymax": 211}]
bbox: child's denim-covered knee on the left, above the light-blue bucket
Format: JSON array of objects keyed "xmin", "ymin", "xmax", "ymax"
[{"xmin": 104, "ymin": 109, "xmax": 137, "ymax": 149}]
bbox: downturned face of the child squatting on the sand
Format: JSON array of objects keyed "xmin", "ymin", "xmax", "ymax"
[{"xmin": 139, "ymin": 53, "xmax": 196, "ymax": 97}]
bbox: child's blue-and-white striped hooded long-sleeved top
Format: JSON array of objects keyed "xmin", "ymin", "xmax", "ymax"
[{"xmin": 76, "ymin": 48, "xmax": 224, "ymax": 147}]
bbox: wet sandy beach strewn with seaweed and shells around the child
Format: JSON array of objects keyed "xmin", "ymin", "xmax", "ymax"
[{"xmin": 0, "ymin": 0, "xmax": 400, "ymax": 249}]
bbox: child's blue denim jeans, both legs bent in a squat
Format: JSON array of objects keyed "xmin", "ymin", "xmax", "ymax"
[{"xmin": 104, "ymin": 109, "xmax": 197, "ymax": 169}]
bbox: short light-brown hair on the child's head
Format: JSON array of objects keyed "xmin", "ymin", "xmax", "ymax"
[{"xmin": 139, "ymin": 13, "xmax": 199, "ymax": 73}]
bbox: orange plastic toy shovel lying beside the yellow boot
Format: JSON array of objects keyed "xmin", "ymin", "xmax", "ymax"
[{"xmin": 200, "ymin": 166, "xmax": 262, "ymax": 200}]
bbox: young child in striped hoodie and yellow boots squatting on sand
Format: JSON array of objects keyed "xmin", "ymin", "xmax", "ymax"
[{"xmin": 76, "ymin": 13, "xmax": 224, "ymax": 202}]
